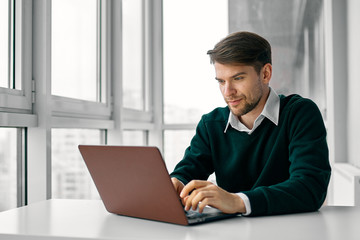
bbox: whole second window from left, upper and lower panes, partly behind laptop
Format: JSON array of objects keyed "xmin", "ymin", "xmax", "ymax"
[{"xmin": 26, "ymin": 0, "xmax": 114, "ymax": 203}]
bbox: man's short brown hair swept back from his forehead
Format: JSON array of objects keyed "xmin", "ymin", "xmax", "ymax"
[{"xmin": 207, "ymin": 32, "xmax": 271, "ymax": 74}]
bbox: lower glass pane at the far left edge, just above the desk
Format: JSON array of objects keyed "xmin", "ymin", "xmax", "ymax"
[{"xmin": 0, "ymin": 128, "xmax": 17, "ymax": 211}]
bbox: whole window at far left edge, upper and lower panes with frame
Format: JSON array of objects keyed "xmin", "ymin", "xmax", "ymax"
[{"xmin": 0, "ymin": 0, "xmax": 31, "ymax": 211}]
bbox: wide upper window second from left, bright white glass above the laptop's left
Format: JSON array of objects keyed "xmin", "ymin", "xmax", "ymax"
[{"xmin": 49, "ymin": 0, "xmax": 111, "ymax": 120}]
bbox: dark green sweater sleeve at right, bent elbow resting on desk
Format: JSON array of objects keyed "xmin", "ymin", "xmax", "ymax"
[{"xmin": 243, "ymin": 99, "xmax": 331, "ymax": 216}]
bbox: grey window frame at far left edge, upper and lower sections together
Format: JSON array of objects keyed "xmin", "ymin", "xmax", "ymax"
[{"xmin": 0, "ymin": 0, "xmax": 32, "ymax": 210}]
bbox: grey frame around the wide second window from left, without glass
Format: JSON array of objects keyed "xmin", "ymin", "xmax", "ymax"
[{"xmin": 26, "ymin": 0, "xmax": 114, "ymax": 203}]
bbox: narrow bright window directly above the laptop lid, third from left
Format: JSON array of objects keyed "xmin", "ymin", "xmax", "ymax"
[{"xmin": 120, "ymin": 0, "xmax": 154, "ymax": 144}]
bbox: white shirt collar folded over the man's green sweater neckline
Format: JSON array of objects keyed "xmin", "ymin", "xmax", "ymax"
[{"xmin": 224, "ymin": 88, "xmax": 280, "ymax": 134}]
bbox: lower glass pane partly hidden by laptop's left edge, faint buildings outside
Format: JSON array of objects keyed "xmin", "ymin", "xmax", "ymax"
[{"xmin": 51, "ymin": 129, "xmax": 101, "ymax": 199}]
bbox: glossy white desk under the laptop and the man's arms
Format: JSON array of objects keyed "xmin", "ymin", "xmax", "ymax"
[{"xmin": 0, "ymin": 200, "xmax": 360, "ymax": 240}]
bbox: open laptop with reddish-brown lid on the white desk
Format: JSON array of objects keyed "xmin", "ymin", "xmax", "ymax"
[{"xmin": 79, "ymin": 145, "xmax": 237, "ymax": 225}]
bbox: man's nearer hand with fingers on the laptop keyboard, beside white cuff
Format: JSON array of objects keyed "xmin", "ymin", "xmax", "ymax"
[{"xmin": 179, "ymin": 180, "xmax": 245, "ymax": 213}]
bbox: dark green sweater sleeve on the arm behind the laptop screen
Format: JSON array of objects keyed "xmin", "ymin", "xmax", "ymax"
[{"xmin": 170, "ymin": 116, "xmax": 214, "ymax": 184}]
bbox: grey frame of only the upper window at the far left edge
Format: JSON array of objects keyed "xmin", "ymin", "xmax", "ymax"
[{"xmin": 0, "ymin": 0, "xmax": 33, "ymax": 114}]
